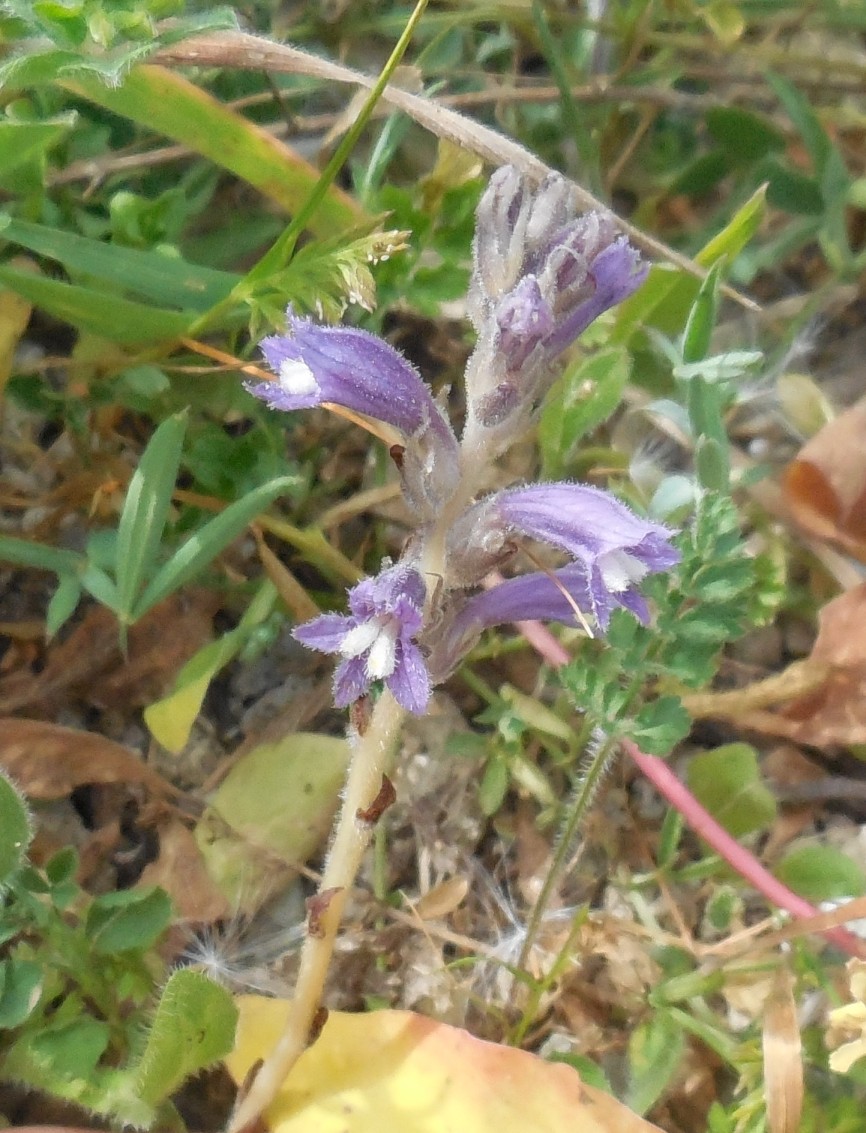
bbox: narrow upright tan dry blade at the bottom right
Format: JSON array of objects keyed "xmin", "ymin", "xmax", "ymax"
[{"xmin": 763, "ymin": 968, "xmax": 803, "ymax": 1133}]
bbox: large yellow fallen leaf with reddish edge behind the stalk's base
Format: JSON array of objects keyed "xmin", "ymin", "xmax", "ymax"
[{"xmin": 227, "ymin": 996, "xmax": 659, "ymax": 1133}]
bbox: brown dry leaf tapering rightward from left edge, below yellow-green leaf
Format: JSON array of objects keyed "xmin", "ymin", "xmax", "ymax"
[{"xmin": 0, "ymin": 717, "xmax": 176, "ymax": 799}]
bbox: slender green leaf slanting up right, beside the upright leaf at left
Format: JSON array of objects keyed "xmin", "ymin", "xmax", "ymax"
[{"xmin": 134, "ymin": 476, "xmax": 297, "ymax": 621}]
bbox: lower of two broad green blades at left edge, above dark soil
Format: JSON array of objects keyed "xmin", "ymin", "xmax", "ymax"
[{"xmin": 0, "ymin": 264, "xmax": 195, "ymax": 346}]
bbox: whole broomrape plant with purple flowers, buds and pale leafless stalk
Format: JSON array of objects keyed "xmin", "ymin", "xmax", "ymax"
[{"xmin": 231, "ymin": 167, "xmax": 680, "ymax": 1133}]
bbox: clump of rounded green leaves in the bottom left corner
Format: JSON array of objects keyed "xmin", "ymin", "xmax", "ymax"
[{"xmin": 0, "ymin": 806, "xmax": 236, "ymax": 1127}]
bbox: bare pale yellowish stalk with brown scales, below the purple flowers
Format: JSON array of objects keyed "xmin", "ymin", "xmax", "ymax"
[{"xmin": 228, "ymin": 690, "xmax": 406, "ymax": 1133}]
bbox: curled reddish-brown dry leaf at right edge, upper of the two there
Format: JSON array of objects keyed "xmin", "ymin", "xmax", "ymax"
[{"xmin": 782, "ymin": 398, "xmax": 866, "ymax": 562}]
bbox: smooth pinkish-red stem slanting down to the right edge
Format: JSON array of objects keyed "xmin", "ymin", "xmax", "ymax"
[{"xmin": 507, "ymin": 607, "xmax": 866, "ymax": 959}]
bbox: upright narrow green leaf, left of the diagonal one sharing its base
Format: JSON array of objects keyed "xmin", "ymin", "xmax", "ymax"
[{"xmin": 114, "ymin": 414, "xmax": 187, "ymax": 624}]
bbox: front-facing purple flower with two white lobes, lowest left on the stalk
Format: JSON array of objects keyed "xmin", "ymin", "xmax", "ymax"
[{"xmin": 295, "ymin": 564, "xmax": 430, "ymax": 715}]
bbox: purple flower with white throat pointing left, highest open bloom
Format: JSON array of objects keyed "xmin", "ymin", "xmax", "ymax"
[{"xmin": 247, "ymin": 307, "xmax": 457, "ymax": 452}]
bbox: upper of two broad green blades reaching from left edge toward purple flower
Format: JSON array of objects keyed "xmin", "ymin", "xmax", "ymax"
[{"xmin": 0, "ymin": 214, "xmax": 240, "ymax": 312}]
